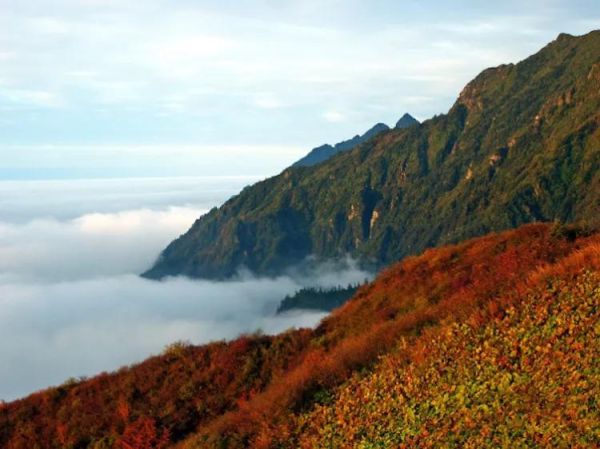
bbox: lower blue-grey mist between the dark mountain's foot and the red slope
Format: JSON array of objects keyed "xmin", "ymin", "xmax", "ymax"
[{"xmin": 0, "ymin": 275, "xmax": 332, "ymax": 400}]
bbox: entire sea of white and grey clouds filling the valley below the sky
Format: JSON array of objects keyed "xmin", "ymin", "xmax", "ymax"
[{"xmin": 0, "ymin": 178, "xmax": 369, "ymax": 400}]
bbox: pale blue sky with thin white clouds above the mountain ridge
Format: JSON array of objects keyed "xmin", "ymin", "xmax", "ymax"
[{"xmin": 0, "ymin": 0, "xmax": 600, "ymax": 178}]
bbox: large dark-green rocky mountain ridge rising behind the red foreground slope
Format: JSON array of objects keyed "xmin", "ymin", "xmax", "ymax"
[{"xmin": 145, "ymin": 31, "xmax": 600, "ymax": 278}]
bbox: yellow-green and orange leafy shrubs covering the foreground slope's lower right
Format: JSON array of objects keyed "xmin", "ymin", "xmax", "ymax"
[{"xmin": 292, "ymin": 272, "xmax": 600, "ymax": 449}]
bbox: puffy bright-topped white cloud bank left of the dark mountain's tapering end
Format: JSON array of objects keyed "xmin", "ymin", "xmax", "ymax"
[{"xmin": 0, "ymin": 207, "xmax": 206, "ymax": 282}]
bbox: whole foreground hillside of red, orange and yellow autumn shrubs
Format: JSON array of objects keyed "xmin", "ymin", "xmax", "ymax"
[{"xmin": 0, "ymin": 224, "xmax": 600, "ymax": 449}]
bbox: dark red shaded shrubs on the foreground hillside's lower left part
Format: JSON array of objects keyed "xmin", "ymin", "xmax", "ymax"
[{"xmin": 0, "ymin": 330, "xmax": 310, "ymax": 449}]
